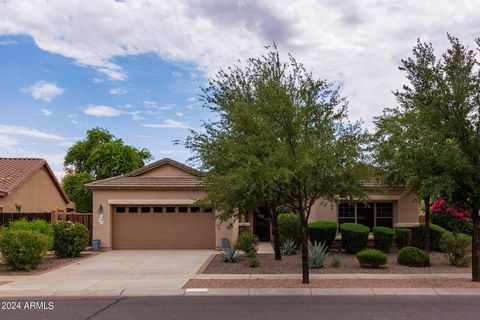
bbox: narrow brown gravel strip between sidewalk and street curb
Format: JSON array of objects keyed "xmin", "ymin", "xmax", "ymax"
[{"xmin": 184, "ymin": 279, "xmax": 480, "ymax": 289}]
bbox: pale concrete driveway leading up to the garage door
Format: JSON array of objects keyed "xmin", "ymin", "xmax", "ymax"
[{"xmin": 0, "ymin": 250, "xmax": 214, "ymax": 296}]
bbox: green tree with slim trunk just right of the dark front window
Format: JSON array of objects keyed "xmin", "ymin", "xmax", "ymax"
[{"xmin": 374, "ymin": 41, "xmax": 465, "ymax": 251}]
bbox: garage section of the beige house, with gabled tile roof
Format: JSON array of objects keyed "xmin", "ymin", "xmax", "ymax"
[{"xmin": 86, "ymin": 159, "xmax": 222, "ymax": 249}]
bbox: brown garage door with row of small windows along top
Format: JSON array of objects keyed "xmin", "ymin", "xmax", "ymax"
[{"xmin": 113, "ymin": 206, "xmax": 215, "ymax": 249}]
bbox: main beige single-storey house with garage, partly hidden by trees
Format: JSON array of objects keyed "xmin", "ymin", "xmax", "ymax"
[{"xmin": 86, "ymin": 159, "xmax": 420, "ymax": 249}]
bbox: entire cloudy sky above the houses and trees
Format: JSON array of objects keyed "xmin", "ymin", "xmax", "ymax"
[{"xmin": 0, "ymin": 0, "xmax": 480, "ymax": 177}]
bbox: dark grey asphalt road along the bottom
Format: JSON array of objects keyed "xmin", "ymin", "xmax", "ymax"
[{"xmin": 0, "ymin": 296, "xmax": 480, "ymax": 320}]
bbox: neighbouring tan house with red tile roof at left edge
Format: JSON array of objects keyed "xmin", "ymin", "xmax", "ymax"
[{"xmin": 0, "ymin": 158, "xmax": 72, "ymax": 213}]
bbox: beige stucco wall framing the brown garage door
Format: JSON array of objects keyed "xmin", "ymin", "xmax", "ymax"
[{"xmin": 93, "ymin": 190, "xmax": 238, "ymax": 249}]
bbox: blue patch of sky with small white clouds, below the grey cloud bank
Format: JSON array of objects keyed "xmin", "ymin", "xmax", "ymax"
[{"xmin": 0, "ymin": 36, "xmax": 209, "ymax": 175}]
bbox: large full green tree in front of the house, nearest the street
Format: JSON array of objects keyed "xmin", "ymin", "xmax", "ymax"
[{"xmin": 187, "ymin": 49, "xmax": 366, "ymax": 283}]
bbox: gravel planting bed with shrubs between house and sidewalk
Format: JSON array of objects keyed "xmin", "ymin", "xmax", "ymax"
[{"xmin": 202, "ymin": 252, "xmax": 471, "ymax": 274}]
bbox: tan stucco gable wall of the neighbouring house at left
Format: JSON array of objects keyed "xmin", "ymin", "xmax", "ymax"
[{"xmin": 0, "ymin": 168, "xmax": 66, "ymax": 212}]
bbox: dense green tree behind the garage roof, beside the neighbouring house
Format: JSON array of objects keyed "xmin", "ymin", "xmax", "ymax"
[{"xmin": 62, "ymin": 128, "xmax": 152, "ymax": 212}]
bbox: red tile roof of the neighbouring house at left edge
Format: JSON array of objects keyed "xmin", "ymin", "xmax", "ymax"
[{"xmin": 0, "ymin": 158, "xmax": 69, "ymax": 203}]
